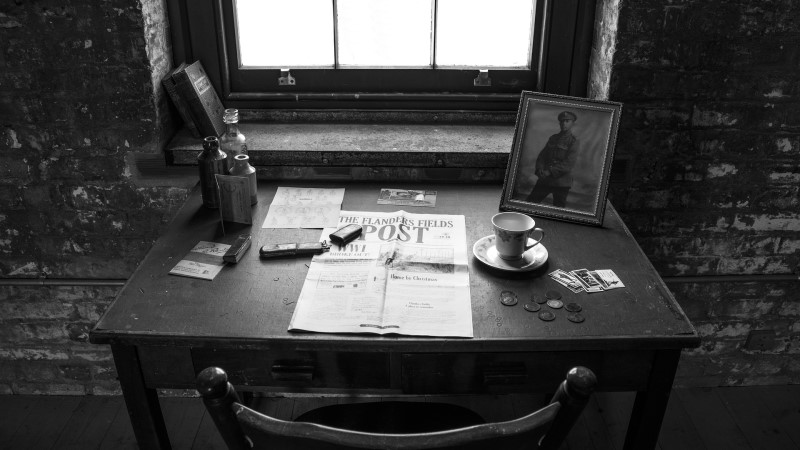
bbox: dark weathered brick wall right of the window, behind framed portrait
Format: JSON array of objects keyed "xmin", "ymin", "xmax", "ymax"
[{"xmin": 609, "ymin": 0, "xmax": 800, "ymax": 385}]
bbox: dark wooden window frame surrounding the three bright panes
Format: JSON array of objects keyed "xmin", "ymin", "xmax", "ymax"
[{"xmin": 167, "ymin": 0, "xmax": 596, "ymax": 112}]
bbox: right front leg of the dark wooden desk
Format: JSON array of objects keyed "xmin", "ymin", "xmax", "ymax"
[{"xmin": 624, "ymin": 350, "xmax": 681, "ymax": 450}]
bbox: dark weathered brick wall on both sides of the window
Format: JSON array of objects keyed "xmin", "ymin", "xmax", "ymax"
[{"xmin": 0, "ymin": 0, "xmax": 800, "ymax": 394}]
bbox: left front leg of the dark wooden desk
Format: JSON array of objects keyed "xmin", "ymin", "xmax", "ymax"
[{"xmin": 111, "ymin": 345, "xmax": 171, "ymax": 450}]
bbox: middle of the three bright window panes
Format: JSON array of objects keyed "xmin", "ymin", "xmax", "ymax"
[{"xmin": 337, "ymin": 0, "xmax": 433, "ymax": 67}]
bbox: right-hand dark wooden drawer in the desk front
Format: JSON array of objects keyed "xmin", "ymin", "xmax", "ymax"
[{"xmin": 401, "ymin": 351, "xmax": 653, "ymax": 394}]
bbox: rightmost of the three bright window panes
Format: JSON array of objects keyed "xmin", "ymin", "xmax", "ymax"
[{"xmin": 436, "ymin": 0, "xmax": 534, "ymax": 68}]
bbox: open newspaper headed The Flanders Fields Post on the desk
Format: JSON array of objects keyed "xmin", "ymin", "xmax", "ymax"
[{"xmin": 289, "ymin": 211, "xmax": 473, "ymax": 337}]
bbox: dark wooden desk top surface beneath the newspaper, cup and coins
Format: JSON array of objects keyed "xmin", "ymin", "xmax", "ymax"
[{"xmin": 90, "ymin": 180, "xmax": 699, "ymax": 352}]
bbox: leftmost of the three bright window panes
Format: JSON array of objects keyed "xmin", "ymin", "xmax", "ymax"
[{"xmin": 233, "ymin": 0, "xmax": 333, "ymax": 68}]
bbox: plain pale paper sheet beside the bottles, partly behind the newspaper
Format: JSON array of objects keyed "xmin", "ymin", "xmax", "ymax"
[{"xmin": 261, "ymin": 187, "xmax": 344, "ymax": 228}]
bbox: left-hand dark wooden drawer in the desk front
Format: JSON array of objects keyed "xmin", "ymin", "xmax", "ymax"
[{"xmin": 192, "ymin": 349, "xmax": 389, "ymax": 389}]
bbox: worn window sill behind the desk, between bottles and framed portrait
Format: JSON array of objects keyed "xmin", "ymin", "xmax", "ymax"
[{"xmin": 166, "ymin": 121, "xmax": 514, "ymax": 182}]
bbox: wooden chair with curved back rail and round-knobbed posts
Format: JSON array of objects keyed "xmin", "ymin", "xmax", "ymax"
[{"xmin": 197, "ymin": 367, "xmax": 597, "ymax": 450}]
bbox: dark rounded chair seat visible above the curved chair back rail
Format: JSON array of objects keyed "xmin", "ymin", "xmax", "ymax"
[{"xmin": 295, "ymin": 401, "xmax": 486, "ymax": 434}]
